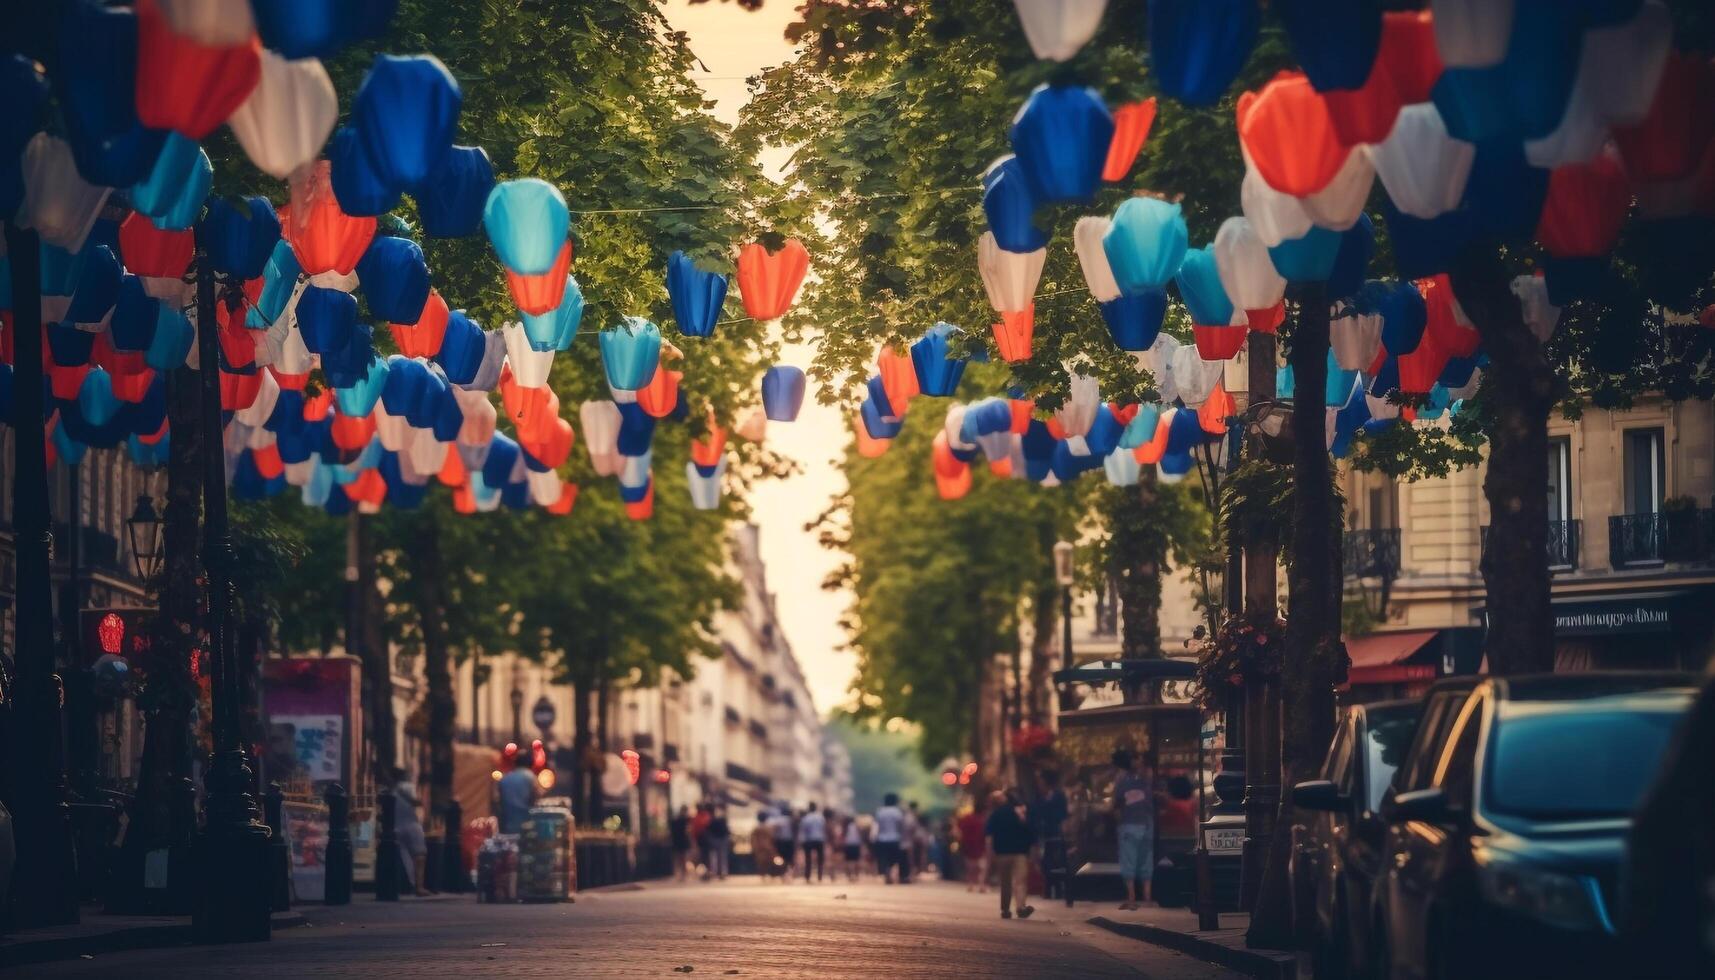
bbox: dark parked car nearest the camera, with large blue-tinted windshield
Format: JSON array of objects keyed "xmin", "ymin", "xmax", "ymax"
[{"xmin": 1372, "ymin": 673, "xmax": 1696, "ymax": 978}]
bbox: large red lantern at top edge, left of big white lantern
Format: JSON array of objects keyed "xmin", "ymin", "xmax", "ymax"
[{"xmin": 132, "ymin": 0, "xmax": 262, "ymax": 141}]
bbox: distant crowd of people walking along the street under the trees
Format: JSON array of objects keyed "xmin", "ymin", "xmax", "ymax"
[{"xmin": 669, "ymin": 748, "xmax": 1156, "ymax": 918}]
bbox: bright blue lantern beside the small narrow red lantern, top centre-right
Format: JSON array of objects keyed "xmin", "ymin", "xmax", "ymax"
[{"xmin": 1002, "ymin": 86, "xmax": 1111, "ymax": 206}]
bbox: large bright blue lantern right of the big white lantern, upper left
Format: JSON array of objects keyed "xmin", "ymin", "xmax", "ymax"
[{"xmin": 352, "ymin": 55, "xmax": 465, "ymax": 191}]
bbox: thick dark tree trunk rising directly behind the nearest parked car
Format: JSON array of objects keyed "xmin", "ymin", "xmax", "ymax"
[{"xmin": 1451, "ymin": 245, "xmax": 1554, "ymax": 675}]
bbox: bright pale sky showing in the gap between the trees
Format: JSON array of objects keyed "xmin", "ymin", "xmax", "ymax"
[{"xmin": 665, "ymin": 0, "xmax": 856, "ymax": 712}]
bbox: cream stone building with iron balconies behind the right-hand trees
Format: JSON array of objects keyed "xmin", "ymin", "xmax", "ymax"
[{"xmin": 1341, "ymin": 391, "xmax": 1715, "ymax": 695}]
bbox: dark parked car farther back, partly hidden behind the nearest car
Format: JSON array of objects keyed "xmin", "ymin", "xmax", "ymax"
[{"xmin": 1291, "ymin": 693, "xmax": 1426, "ymax": 980}]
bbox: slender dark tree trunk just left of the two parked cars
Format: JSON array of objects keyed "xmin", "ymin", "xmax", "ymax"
[{"xmin": 1245, "ymin": 287, "xmax": 1346, "ymax": 949}]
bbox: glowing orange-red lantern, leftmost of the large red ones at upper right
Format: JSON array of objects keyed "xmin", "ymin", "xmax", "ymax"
[{"xmin": 1238, "ymin": 72, "xmax": 1353, "ymax": 197}]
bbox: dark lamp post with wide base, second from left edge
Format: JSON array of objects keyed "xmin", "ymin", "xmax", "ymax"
[{"xmin": 194, "ymin": 241, "xmax": 273, "ymax": 942}]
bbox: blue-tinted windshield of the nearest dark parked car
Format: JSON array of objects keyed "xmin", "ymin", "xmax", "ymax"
[{"xmin": 1485, "ymin": 697, "xmax": 1689, "ymax": 820}]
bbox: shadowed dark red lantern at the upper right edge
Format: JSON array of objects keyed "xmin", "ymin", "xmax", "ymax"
[{"xmin": 1614, "ymin": 51, "xmax": 1715, "ymax": 182}]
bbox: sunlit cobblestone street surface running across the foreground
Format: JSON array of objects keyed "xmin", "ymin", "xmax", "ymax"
[{"xmin": 27, "ymin": 879, "xmax": 1237, "ymax": 980}]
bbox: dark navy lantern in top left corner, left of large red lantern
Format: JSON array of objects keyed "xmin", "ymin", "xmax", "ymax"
[{"xmin": 57, "ymin": 0, "xmax": 166, "ymax": 187}]
